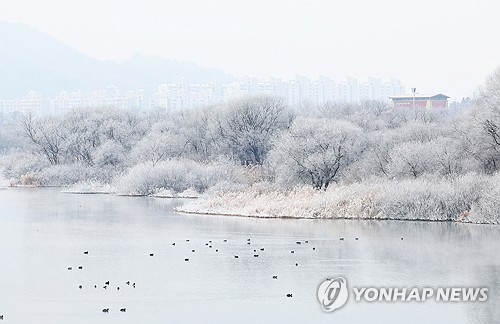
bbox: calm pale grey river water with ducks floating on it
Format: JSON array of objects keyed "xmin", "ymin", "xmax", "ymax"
[{"xmin": 0, "ymin": 188, "xmax": 500, "ymax": 324}]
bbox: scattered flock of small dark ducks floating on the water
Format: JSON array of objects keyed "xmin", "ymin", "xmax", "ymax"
[{"xmin": 57, "ymin": 237, "xmax": 403, "ymax": 320}]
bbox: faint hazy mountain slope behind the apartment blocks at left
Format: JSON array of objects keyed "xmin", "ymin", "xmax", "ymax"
[{"xmin": 0, "ymin": 22, "xmax": 233, "ymax": 99}]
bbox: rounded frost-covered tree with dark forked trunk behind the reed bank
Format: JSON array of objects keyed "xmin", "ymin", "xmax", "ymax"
[{"xmin": 271, "ymin": 117, "xmax": 364, "ymax": 189}]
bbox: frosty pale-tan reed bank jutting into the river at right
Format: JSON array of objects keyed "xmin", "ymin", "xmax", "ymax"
[{"xmin": 176, "ymin": 175, "xmax": 500, "ymax": 224}]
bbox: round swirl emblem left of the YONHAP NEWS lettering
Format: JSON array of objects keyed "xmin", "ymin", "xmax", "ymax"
[{"xmin": 318, "ymin": 277, "xmax": 349, "ymax": 312}]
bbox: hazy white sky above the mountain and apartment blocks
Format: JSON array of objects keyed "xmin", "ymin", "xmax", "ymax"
[{"xmin": 0, "ymin": 0, "xmax": 500, "ymax": 98}]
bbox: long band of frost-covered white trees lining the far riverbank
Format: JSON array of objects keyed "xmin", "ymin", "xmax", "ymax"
[{"xmin": 0, "ymin": 70, "xmax": 500, "ymax": 189}]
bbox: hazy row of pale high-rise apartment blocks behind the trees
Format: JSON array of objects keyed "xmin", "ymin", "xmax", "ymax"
[{"xmin": 0, "ymin": 75, "xmax": 406, "ymax": 116}]
